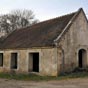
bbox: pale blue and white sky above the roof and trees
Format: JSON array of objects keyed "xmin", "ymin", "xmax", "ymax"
[{"xmin": 0, "ymin": 0, "xmax": 88, "ymax": 21}]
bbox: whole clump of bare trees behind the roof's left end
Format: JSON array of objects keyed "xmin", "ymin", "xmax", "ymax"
[{"xmin": 0, "ymin": 9, "xmax": 38, "ymax": 34}]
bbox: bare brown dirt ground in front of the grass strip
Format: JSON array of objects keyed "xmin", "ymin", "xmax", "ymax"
[{"xmin": 0, "ymin": 78, "xmax": 88, "ymax": 88}]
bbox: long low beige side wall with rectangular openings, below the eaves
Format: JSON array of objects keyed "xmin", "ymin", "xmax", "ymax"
[{"xmin": 0, "ymin": 48, "xmax": 58, "ymax": 76}]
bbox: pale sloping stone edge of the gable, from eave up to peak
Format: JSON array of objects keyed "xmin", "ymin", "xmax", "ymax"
[{"xmin": 54, "ymin": 8, "xmax": 84, "ymax": 46}]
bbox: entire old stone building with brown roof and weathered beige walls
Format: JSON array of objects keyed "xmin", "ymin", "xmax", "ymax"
[{"xmin": 0, "ymin": 8, "xmax": 88, "ymax": 76}]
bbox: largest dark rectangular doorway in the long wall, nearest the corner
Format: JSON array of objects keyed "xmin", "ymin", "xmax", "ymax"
[{"xmin": 29, "ymin": 52, "xmax": 39, "ymax": 72}]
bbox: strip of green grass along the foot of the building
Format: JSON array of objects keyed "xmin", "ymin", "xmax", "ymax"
[{"xmin": 0, "ymin": 72, "xmax": 88, "ymax": 81}]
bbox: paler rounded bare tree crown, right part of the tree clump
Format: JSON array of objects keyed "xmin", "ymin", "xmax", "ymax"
[{"xmin": 10, "ymin": 10, "xmax": 38, "ymax": 28}]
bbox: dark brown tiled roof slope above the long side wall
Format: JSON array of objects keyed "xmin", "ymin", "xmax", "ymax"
[{"xmin": 0, "ymin": 12, "xmax": 77, "ymax": 49}]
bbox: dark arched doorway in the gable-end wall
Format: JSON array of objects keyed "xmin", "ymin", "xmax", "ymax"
[{"xmin": 78, "ymin": 49, "xmax": 87, "ymax": 68}]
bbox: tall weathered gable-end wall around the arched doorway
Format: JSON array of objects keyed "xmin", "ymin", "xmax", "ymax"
[{"xmin": 59, "ymin": 11, "xmax": 88, "ymax": 71}]
